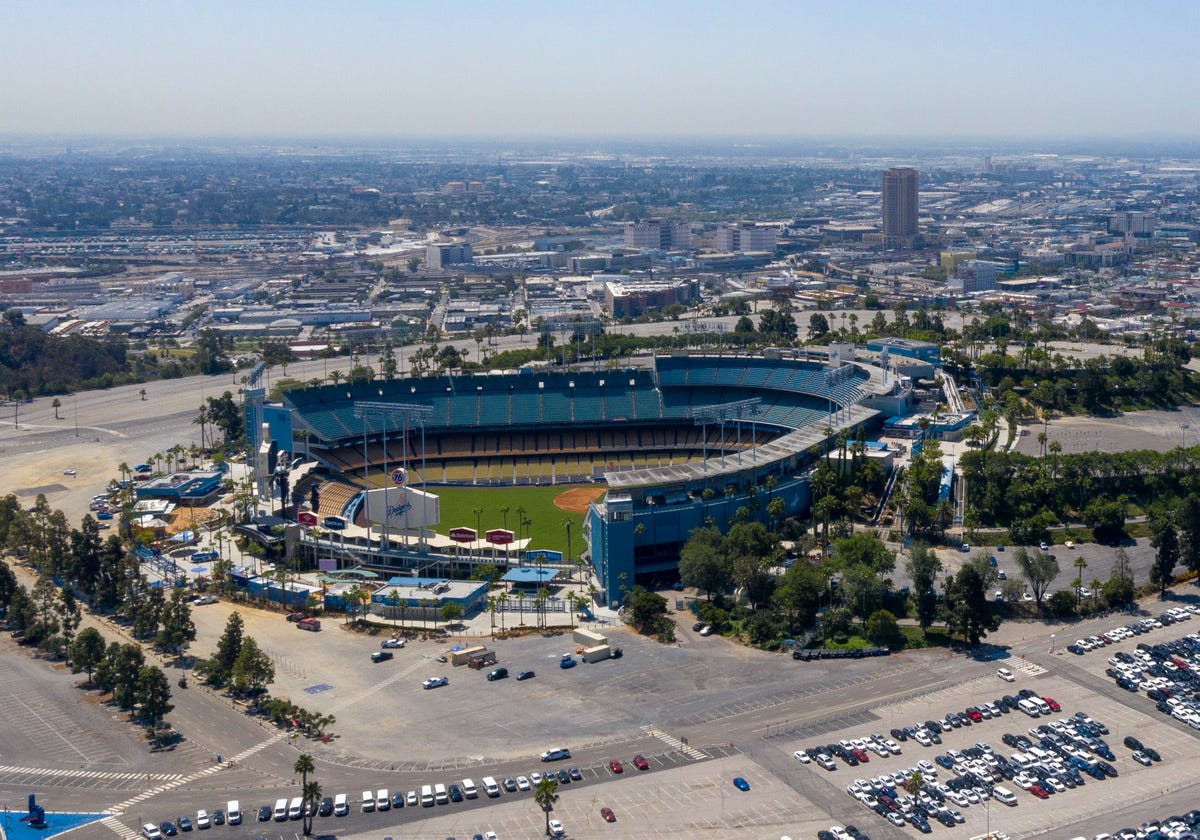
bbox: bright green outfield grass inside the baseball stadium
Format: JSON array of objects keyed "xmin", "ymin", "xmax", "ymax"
[{"xmin": 428, "ymin": 485, "xmax": 587, "ymax": 557}]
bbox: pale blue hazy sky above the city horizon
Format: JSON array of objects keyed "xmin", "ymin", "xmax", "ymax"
[{"xmin": 0, "ymin": 0, "xmax": 1200, "ymax": 138}]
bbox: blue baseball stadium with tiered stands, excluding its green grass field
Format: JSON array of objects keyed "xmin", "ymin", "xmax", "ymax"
[{"xmin": 276, "ymin": 346, "xmax": 911, "ymax": 605}]
